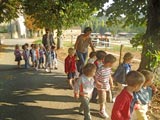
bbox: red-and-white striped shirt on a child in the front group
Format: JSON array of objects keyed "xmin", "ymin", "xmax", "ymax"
[{"xmin": 95, "ymin": 66, "xmax": 111, "ymax": 91}]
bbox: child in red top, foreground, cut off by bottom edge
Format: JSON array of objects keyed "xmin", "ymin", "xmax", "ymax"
[{"xmin": 111, "ymin": 71, "xmax": 145, "ymax": 120}]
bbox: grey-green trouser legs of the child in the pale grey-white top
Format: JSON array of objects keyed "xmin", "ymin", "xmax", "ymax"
[{"xmin": 80, "ymin": 97, "xmax": 91, "ymax": 120}]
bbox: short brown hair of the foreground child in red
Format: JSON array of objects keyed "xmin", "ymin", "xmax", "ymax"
[{"xmin": 126, "ymin": 71, "xmax": 145, "ymax": 86}]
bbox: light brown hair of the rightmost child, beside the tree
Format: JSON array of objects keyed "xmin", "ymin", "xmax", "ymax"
[{"xmin": 141, "ymin": 70, "xmax": 154, "ymax": 82}]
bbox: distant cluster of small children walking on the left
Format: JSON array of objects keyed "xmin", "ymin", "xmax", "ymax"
[{"xmin": 14, "ymin": 43, "xmax": 57, "ymax": 72}]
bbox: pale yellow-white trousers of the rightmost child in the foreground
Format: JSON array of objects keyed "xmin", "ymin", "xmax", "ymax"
[{"xmin": 135, "ymin": 105, "xmax": 148, "ymax": 120}]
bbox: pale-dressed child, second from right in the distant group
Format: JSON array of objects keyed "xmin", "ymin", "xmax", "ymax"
[{"xmin": 45, "ymin": 46, "xmax": 52, "ymax": 73}]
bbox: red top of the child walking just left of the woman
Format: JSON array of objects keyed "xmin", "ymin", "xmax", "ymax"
[{"xmin": 65, "ymin": 55, "xmax": 76, "ymax": 73}]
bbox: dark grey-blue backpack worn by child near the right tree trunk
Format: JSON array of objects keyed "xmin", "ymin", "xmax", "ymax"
[{"xmin": 113, "ymin": 63, "xmax": 126, "ymax": 84}]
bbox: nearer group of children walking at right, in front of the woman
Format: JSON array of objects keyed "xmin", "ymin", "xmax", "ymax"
[{"xmin": 65, "ymin": 48, "xmax": 154, "ymax": 120}]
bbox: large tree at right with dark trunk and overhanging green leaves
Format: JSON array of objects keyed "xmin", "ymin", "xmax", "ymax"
[{"xmin": 99, "ymin": 0, "xmax": 160, "ymax": 70}]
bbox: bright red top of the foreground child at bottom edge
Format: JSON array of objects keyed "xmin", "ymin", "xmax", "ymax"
[{"xmin": 111, "ymin": 88, "xmax": 133, "ymax": 120}]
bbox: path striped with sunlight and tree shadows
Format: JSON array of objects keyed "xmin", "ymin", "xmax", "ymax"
[{"xmin": 0, "ymin": 47, "xmax": 112, "ymax": 120}]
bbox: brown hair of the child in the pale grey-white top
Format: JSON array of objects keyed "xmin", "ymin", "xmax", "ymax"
[{"xmin": 83, "ymin": 63, "xmax": 97, "ymax": 75}]
